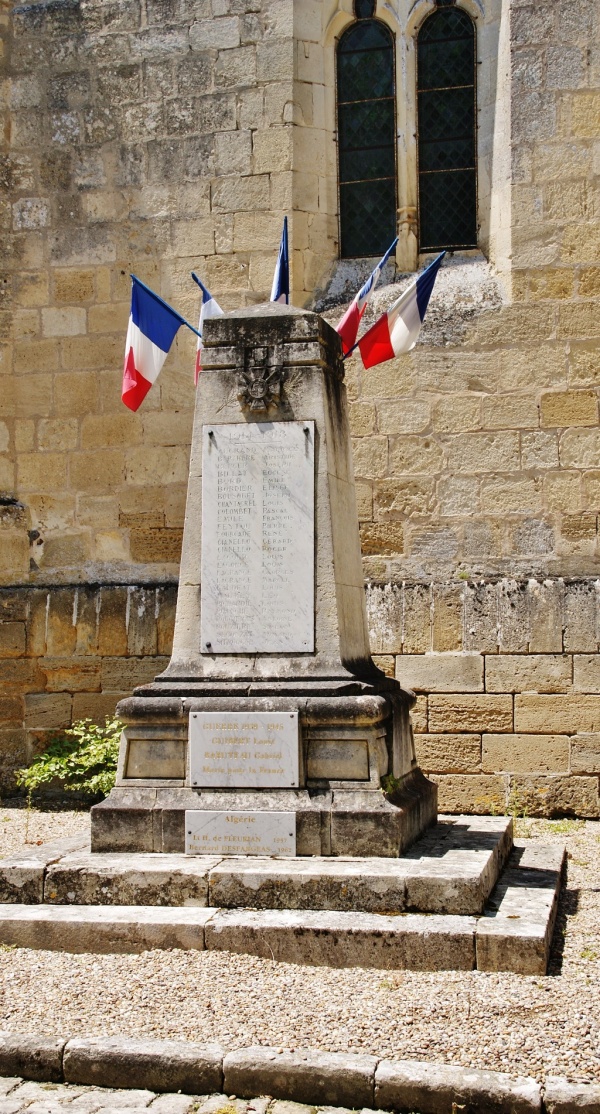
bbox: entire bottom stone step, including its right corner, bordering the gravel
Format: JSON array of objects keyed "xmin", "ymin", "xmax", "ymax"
[{"xmin": 0, "ymin": 847, "xmax": 564, "ymax": 975}]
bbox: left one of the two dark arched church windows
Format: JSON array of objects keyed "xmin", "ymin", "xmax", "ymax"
[{"xmin": 337, "ymin": 16, "xmax": 396, "ymax": 258}]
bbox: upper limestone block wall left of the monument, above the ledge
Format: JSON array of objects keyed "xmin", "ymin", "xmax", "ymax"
[{"xmin": 0, "ymin": 0, "xmax": 294, "ymax": 584}]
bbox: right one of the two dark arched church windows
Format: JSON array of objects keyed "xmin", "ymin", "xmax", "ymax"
[{"xmin": 417, "ymin": 7, "xmax": 478, "ymax": 252}]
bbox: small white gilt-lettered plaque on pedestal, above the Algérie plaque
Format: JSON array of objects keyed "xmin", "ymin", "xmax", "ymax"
[{"xmin": 189, "ymin": 712, "xmax": 299, "ymax": 789}]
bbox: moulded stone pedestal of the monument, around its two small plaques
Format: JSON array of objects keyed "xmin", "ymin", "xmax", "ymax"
[{"xmin": 91, "ymin": 675, "xmax": 437, "ymax": 858}]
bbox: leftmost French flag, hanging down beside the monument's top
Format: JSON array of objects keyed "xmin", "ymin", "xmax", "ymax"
[{"xmin": 121, "ymin": 275, "xmax": 187, "ymax": 410}]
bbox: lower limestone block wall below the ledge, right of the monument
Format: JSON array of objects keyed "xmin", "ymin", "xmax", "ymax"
[{"xmin": 367, "ymin": 578, "xmax": 600, "ymax": 817}]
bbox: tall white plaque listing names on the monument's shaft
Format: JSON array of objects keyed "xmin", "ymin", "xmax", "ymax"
[{"xmin": 200, "ymin": 421, "xmax": 315, "ymax": 654}]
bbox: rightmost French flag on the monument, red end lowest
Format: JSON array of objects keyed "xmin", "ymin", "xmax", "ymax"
[{"xmin": 357, "ymin": 252, "xmax": 445, "ymax": 368}]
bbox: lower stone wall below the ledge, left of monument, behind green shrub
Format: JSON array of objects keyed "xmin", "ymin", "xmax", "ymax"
[{"xmin": 0, "ymin": 584, "xmax": 177, "ymax": 794}]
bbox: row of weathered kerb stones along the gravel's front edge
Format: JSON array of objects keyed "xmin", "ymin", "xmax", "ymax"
[{"xmin": 0, "ymin": 1033, "xmax": 600, "ymax": 1114}]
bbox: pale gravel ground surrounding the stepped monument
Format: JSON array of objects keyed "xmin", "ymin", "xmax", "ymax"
[{"xmin": 0, "ymin": 809, "xmax": 600, "ymax": 1083}]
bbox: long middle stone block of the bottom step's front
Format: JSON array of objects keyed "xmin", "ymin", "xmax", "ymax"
[{"xmin": 205, "ymin": 910, "xmax": 475, "ymax": 970}]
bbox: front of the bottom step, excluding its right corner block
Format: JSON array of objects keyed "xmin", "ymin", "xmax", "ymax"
[{"xmin": 0, "ymin": 905, "xmax": 475, "ymax": 970}]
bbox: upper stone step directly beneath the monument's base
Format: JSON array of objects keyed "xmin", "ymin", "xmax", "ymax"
[{"xmin": 0, "ymin": 817, "xmax": 512, "ymax": 916}]
